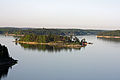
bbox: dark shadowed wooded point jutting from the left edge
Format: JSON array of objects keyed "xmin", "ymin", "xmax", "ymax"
[{"xmin": 0, "ymin": 44, "xmax": 17, "ymax": 66}]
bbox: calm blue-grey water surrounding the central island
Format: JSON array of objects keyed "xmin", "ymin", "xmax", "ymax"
[{"xmin": 0, "ymin": 36, "xmax": 120, "ymax": 80}]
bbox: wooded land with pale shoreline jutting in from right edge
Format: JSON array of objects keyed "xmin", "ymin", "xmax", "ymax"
[{"xmin": 97, "ymin": 30, "xmax": 120, "ymax": 38}]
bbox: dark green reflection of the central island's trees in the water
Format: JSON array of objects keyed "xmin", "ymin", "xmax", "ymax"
[{"xmin": 20, "ymin": 43, "xmax": 81, "ymax": 52}]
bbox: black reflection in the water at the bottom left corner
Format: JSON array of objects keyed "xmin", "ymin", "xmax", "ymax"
[{"xmin": 0, "ymin": 65, "xmax": 15, "ymax": 80}]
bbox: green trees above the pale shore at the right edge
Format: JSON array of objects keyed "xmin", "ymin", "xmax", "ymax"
[{"xmin": 98, "ymin": 30, "xmax": 120, "ymax": 36}]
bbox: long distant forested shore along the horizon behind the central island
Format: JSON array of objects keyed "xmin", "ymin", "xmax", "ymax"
[{"xmin": 0, "ymin": 27, "xmax": 105, "ymax": 36}]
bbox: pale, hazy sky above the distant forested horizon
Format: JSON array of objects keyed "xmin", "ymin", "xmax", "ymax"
[{"xmin": 0, "ymin": 0, "xmax": 120, "ymax": 30}]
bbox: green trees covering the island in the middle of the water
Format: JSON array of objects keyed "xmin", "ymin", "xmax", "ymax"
[{"xmin": 19, "ymin": 34, "xmax": 80, "ymax": 43}]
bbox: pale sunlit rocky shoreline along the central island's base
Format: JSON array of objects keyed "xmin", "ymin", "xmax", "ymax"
[{"xmin": 14, "ymin": 41, "xmax": 84, "ymax": 48}]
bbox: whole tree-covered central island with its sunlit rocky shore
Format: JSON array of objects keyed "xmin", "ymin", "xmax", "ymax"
[{"xmin": 15, "ymin": 34, "xmax": 87, "ymax": 48}]
